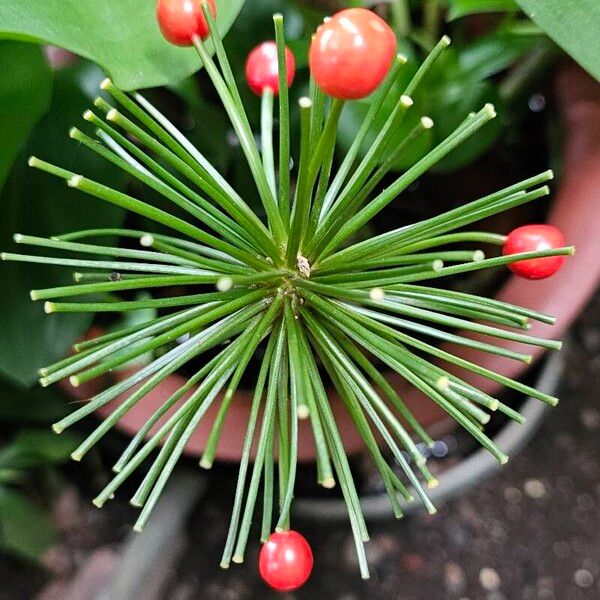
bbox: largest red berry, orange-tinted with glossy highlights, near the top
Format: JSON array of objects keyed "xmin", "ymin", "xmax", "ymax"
[{"xmin": 308, "ymin": 8, "xmax": 396, "ymax": 100}]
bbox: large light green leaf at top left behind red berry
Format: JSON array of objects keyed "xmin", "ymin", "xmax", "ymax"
[{"xmin": 0, "ymin": 0, "xmax": 244, "ymax": 90}]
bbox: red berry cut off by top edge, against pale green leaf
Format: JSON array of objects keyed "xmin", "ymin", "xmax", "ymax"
[{"xmin": 156, "ymin": 0, "xmax": 217, "ymax": 46}]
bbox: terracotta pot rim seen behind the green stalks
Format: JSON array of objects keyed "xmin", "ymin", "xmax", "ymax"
[{"xmin": 64, "ymin": 65, "xmax": 600, "ymax": 461}]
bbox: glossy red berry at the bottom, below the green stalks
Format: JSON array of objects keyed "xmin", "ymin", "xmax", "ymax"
[{"xmin": 258, "ymin": 531, "xmax": 313, "ymax": 592}]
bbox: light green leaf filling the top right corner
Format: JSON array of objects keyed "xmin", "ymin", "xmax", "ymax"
[{"xmin": 510, "ymin": 0, "xmax": 600, "ymax": 80}]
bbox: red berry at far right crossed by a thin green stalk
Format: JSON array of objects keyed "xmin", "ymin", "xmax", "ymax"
[{"xmin": 502, "ymin": 225, "xmax": 565, "ymax": 279}]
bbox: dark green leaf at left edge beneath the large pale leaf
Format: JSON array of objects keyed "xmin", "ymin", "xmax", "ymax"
[{"xmin": 0, "ymin": 41, "xmax": 52, "ymax": 189}]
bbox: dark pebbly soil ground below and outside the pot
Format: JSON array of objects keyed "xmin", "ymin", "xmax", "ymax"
[{"xmin": 0, "ymin": 295, "xmax": 600, "ymax": 600}]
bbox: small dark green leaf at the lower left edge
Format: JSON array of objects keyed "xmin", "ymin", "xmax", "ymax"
[{"xmin": 0, "ymin": 487, "xmax": 55, "ymax": 561}]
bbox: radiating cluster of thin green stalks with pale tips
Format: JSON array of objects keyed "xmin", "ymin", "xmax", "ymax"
[{"xmin": 2, "ymin": 5, "xmax": 572, "ymax": 577}]
